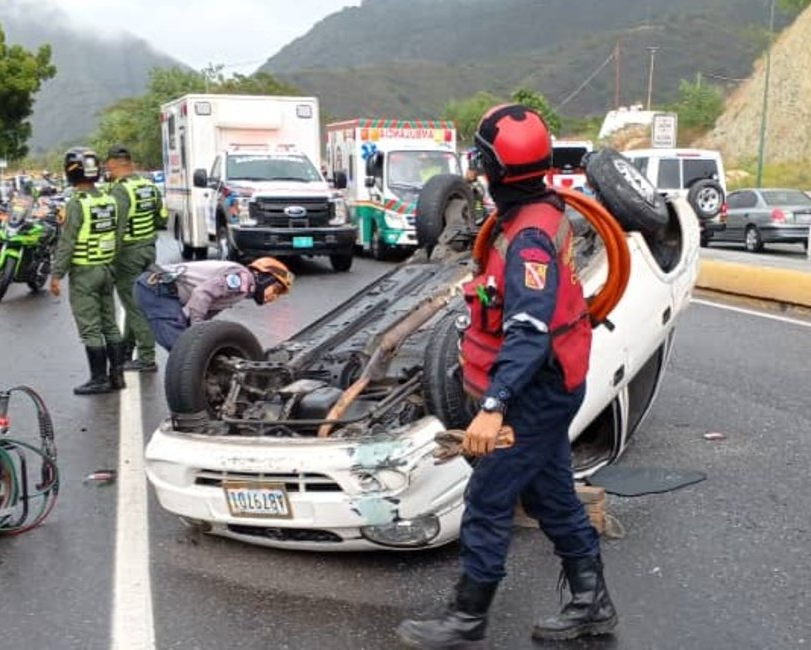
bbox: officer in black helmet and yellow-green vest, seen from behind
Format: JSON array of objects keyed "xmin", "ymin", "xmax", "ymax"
[{"xmin": 50, "ymin": 147, "xmax": 125, "ymax": 395}]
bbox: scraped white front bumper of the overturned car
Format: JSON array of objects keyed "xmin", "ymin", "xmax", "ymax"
[{"xmin": 146, "ymin": 417, "xmax": 471, "ymax": 551}]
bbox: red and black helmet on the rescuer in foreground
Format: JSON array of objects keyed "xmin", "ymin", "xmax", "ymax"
[{"xmin": 474, "ymin": 104, "xmax": 552, "ymax": 183}]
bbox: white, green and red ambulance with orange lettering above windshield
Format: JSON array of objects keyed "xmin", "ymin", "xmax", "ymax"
[{"xmin": 325, "ymin": 118, "xmax": 461, "ymax": 259}]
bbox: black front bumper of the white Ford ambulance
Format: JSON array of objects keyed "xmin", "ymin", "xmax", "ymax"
[{"xmin": 230, "ymin": 225, "xmax": 357, "ymax": 256}]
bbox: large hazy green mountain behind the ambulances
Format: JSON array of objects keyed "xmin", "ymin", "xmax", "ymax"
[{"xmin": 260, "ymin": 0, "xmax": 792, "ymax": 119}]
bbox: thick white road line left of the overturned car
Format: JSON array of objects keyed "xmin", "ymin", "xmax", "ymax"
[{"xmin": 111, "ymin": 373, "xmax": 155, "ymax": 650}]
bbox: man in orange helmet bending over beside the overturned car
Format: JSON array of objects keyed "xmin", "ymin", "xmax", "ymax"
[{"xmin": 135, "ymin": 257, "xmax": 293, "ymax": 350}]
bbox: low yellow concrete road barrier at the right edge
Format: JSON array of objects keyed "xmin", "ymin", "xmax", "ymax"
[{"xmin": 696, "ymin": 259, "xmax": 811, "ymax": 307}]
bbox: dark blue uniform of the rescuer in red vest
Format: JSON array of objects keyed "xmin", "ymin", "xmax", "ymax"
[{"xmin": 460, "ymin": 228, "xmax": 599, "ymax": 583}]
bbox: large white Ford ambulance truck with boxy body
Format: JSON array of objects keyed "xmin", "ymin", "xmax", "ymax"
[{"xmin": 161, "ymin": 94, "xmax": 355, "ymax": 271}]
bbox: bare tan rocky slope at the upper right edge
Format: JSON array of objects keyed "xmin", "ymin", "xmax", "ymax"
[{"xmin": 696, "ymin": 7, "xmax": 811, "ymax": 163}]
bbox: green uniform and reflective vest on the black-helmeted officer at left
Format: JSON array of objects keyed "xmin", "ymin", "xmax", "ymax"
[{"xmin": 52, "ymin": 189, "xmax": 121, "ymax": 348}]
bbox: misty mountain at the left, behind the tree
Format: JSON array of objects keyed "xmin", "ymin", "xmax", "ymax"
[{"xmin": 0, "ymin": 0, "xmax": 180, "ymax": 154}]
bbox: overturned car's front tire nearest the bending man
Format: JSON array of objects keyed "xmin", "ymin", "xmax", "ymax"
[{"xmin": 164, "ymin": 320, "xmax": 264, "ymax": 416}]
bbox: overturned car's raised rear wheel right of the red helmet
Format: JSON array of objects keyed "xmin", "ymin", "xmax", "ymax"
[{"xmin": 586, "ymin": 149, "xmax": 670, "ymax": 235}]
